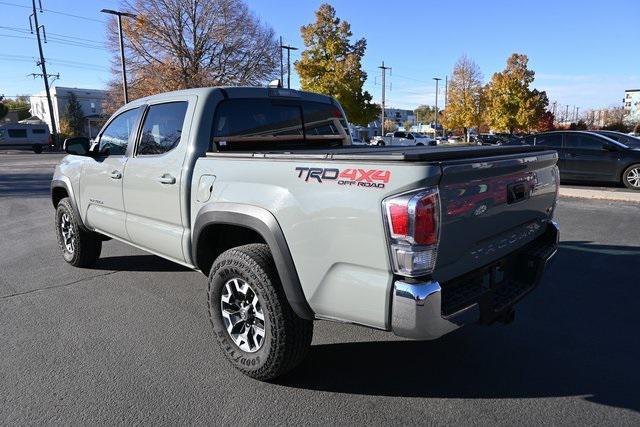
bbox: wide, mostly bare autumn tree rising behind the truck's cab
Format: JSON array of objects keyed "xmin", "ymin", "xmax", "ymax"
[{"xmin": 107, "ymin": 0, "xmax": 279, "ymax": 109}]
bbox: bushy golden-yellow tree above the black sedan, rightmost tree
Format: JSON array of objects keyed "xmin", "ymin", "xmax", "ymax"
[{"xmin": 486, "ymin": 53, "xmax": 549, "ymax": 133}]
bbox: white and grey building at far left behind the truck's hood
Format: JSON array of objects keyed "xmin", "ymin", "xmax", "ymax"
[{"xmin": 29, "ymin": 86, "xmax": 107, "ymax": 138}]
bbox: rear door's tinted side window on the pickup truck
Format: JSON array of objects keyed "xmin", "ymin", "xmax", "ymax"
[{"xmin": 137, "ymin": 101, "xmax": 188, "ymax": 156}]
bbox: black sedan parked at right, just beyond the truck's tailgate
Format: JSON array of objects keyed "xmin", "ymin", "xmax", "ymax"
[{"xmin": 512, "ymin": 131, "xmax": 640, "ymax": 190}]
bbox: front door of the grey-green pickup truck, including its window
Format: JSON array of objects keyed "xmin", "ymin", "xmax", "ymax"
[{"xmin": 80, "ymin": 108, "xmax": 139, "ymax": 239}]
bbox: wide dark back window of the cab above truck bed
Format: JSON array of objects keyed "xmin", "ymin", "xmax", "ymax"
[{"xmin": 213, "ymin": 99, "xmax": 349, "ymax": 151}]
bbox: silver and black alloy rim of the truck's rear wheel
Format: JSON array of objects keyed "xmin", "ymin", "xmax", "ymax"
[{"xmin": 220, "ymin": 278, "xmax": 265, "ymax": 353}]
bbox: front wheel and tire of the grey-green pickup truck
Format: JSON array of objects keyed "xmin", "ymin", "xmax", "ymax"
[{"xmin": 55, "ymin": 197, "xmax": 102, "ymax": 267}]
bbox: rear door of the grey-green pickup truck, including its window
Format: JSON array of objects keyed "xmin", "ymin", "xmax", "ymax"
[{"xmin": 123, "ymin": 98, "xmax": 195, "ymax": 262}]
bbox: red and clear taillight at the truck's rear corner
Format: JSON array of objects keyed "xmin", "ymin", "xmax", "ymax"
[{"xmin": 383, "ymin": 187, "xmax": 440, "ymax": 277}]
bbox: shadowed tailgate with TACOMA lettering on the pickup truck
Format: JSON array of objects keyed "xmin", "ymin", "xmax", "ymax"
[{"xmin": 434, "ymin": 151, "xmax": 558, "ymax": 281}]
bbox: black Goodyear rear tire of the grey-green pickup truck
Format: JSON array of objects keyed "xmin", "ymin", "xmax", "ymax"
[{"xmin": 208, "ymin": 244, "xmax": 313, "ymax": 381}]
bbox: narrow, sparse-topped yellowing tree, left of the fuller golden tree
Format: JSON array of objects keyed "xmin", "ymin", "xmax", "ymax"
[{"xmin": 442, "ymin": 56, "xmax": 482, "ymax": 142}]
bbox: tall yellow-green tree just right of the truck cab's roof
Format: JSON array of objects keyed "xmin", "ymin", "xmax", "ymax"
[{"xmin": 295, "ymin": 4, "xmax": 386, "ymax": 125}]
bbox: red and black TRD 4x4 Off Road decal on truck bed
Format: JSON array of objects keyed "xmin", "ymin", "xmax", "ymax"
[{"xmin": 296, "ymin": 166, "xmax": 391, "ymax": 188}]
